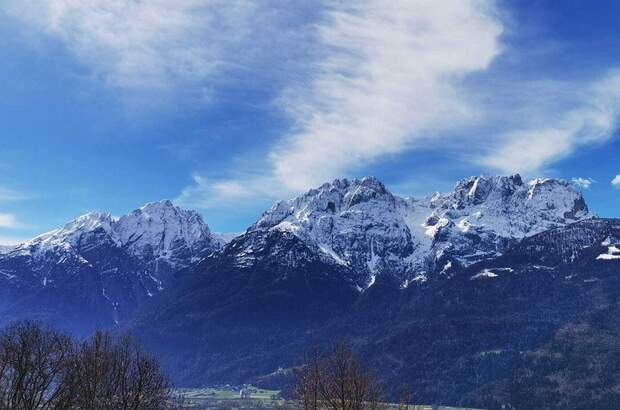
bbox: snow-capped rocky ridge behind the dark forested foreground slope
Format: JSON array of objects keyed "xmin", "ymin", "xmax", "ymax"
[{"xmin": 0, "ymin": 175, "xmax": 596, "ymax": 334}]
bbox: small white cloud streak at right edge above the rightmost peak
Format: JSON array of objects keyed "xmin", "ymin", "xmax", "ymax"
[{"xmin": 479, "ymin": 72, "xmax": 620, "ymax": 173}]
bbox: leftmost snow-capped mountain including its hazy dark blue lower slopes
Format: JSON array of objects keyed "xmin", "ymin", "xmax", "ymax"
[{"xmin": 0, "ymin": 201, "xmax": 223, "ymax": 332}]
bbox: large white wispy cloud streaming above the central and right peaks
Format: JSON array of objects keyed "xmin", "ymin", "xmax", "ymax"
[{"xmin": 170, "ymin": 0, "xmax": 620, "ymax": 211}]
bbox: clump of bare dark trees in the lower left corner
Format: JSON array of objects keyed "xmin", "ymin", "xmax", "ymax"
[{"xmin": 0, "ymin": 322, "xmax": 175, "ymax": 410}]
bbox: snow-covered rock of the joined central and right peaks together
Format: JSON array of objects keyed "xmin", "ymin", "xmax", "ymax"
[{"xmin": 248, "ymin": 175, "xmax": 592, "ymax": 290}]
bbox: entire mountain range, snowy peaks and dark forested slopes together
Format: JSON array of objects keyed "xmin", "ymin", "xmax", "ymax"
[{"xmin": 0, "ymin": 175, "xmax": 620, "ymax": 408}]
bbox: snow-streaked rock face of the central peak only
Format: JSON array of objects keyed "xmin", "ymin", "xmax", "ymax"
[{"xmin": 248, "ymin": 178, "xmax": 419, "ymax": 288}]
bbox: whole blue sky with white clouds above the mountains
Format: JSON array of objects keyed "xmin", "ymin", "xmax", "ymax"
[{"xmin": 0, "ymin": 0, "xmax": 620, "ymax": 243}]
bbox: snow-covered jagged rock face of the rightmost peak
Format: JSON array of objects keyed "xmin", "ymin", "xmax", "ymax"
[{"xmin": 422, "ymin": 175, "xmax": 593, "ymax": 276}]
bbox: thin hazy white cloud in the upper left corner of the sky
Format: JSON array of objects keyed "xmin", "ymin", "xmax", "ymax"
[{"xmin": 0, "ymin": 0, "xmax": 255, "ymax": 90}]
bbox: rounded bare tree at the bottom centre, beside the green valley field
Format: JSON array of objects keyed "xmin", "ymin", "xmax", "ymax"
[{"xmin": 295, "ymin": 343, "xmax": 383, "ymax": 410}]
